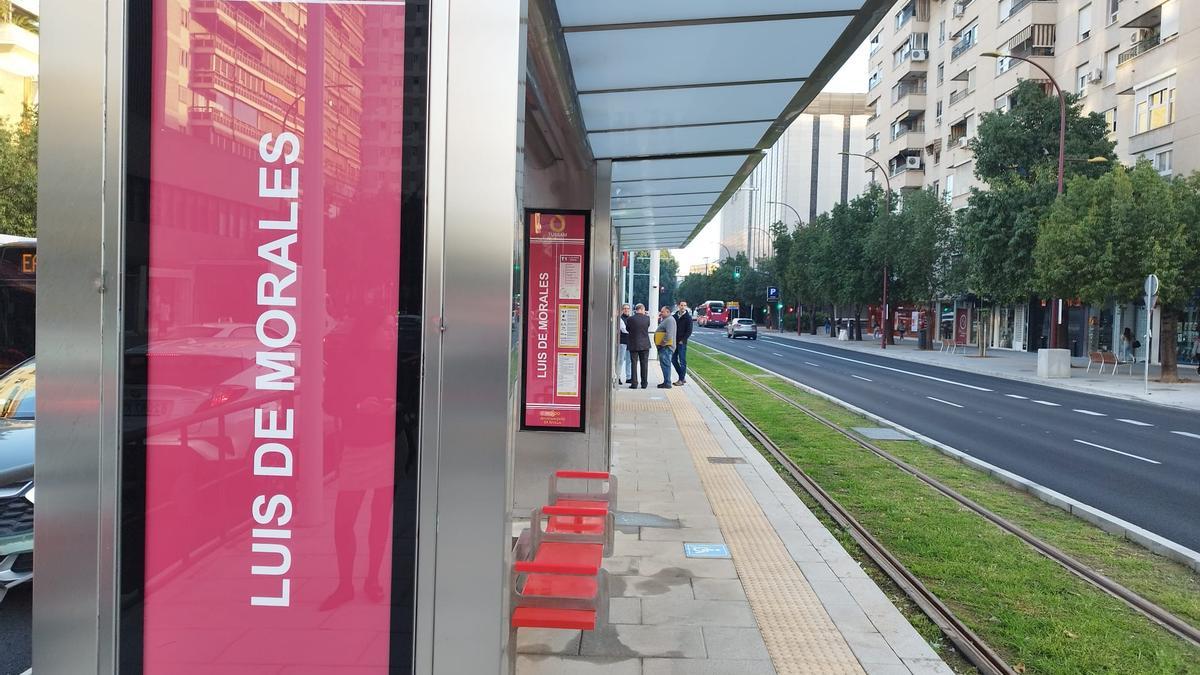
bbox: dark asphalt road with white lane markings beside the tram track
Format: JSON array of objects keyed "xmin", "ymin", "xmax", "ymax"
[{"xmin": 691, "ymin": 328, "xmax": 1200, "ymax": 550}]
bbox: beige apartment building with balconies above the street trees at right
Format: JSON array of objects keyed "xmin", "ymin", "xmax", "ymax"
[{"xmin": 866, "ymin": 0, "xmax": 1200, "ymax": 360}]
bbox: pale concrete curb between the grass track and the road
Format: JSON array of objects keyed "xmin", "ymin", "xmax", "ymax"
[{"xmin": 700, "ymin": 350, "xmax": 1200, "ymax": 572}]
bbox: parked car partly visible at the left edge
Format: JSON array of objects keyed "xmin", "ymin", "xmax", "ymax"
[{"xmin": 0, "ymin": 359, "xmax": 35, "ymax": 601}]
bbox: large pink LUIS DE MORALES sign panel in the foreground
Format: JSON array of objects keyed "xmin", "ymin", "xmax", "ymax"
[{"xmin": 133, "ymin": 0, "xmax": 419, "ymax": 675}]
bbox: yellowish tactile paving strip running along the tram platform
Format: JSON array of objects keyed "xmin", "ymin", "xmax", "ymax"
[{"xmin": 670, "ymin": 392, "xmax": 863, "ymax": 675}]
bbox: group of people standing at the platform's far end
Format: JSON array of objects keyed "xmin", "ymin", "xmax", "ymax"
[{"xmin": 617, "ymin": 300, "xmax": 692, "ymax": 389}]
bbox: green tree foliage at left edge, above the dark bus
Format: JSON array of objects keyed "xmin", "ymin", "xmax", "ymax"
[{"xmin": 0, "ymin": 109, "xmax": 37, "ymax": 237}]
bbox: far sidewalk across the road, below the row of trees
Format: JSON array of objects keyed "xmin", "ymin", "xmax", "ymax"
[{"xmin": 763, "ymin": 329, "xmax": 1200, "ymax": 411}]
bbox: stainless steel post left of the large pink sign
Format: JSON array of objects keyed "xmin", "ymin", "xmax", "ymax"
[{"xmin": 34, "ymin": 1, "xmax": 125, "ymax": 674}]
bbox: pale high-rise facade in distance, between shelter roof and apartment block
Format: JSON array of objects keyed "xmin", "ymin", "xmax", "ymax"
[{"xmin": 719, "ymin": 94, "xmax": 868, "ymax": 261}]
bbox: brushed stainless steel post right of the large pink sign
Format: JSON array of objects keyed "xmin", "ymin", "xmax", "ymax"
[{"xmin": 421, "ymin": 0, "xmax": 524, "ymax": 675}]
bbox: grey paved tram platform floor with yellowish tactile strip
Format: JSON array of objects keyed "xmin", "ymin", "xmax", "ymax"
[{"xmin": 517, "ymin": 387, "xmax": 950, "ymax": 675}]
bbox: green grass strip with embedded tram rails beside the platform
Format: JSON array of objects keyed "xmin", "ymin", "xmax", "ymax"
[{"xmin": 689, "ymin": 348, "xmax": 1200, "ymax": 674}]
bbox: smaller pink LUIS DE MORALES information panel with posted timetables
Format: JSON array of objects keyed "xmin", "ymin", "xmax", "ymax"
[{"xmin": 521, "ymin": 210, "xmax": 589, "ymax": 431}]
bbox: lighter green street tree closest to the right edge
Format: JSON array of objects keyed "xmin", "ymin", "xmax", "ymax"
[{"xmin": 1033, "ymin": 161, "xmax": 1200, "ymax": 382}]
